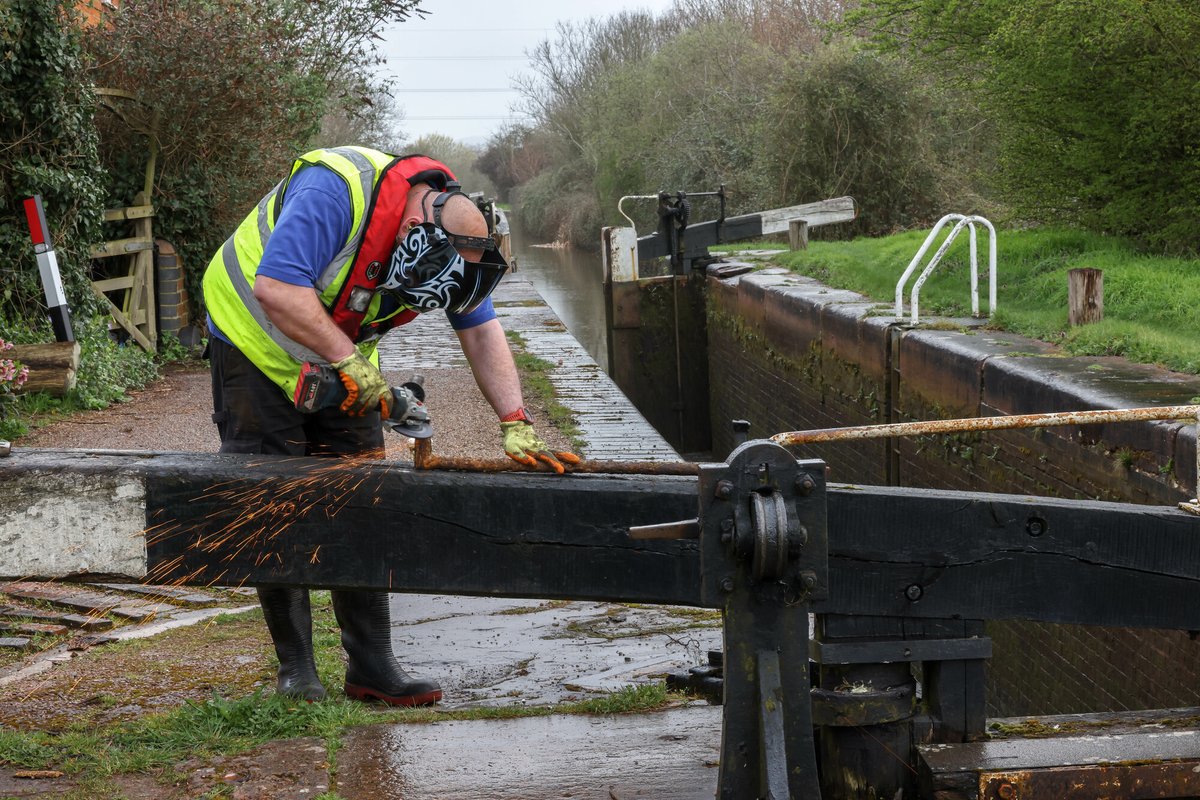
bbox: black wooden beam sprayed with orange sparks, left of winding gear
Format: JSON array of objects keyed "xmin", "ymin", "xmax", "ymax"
[{"xmin": 0, "ymin": 451, "xmax": 701, "ymax": 604}]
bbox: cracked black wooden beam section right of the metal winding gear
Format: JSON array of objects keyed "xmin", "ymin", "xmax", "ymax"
[{"xmin": 814, "ymin": 487, "xmax": 1200, "ymax": 630}]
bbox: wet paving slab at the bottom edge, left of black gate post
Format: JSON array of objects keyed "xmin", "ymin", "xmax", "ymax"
[{"xmin": 337, "ymin": 705, "xmax": 721, "ymax": 800}]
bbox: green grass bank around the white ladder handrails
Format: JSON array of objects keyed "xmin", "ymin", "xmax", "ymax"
[{"xmin": 721, "ymin": 228, "xmax": 1200, "ymax": 373}]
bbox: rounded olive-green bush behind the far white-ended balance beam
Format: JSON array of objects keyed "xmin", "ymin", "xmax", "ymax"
[{"xmin": 755, "ymin": 42, "xmax": 979, "ymax": 235}]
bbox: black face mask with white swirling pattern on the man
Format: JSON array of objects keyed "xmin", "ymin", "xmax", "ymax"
[{"xmin": 379, "ymin": 222, "xmax": 509, "ymax": 313}]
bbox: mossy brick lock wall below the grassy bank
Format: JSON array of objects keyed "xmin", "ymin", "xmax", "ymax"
[{"xmin": 708, "ymin": 270, "xmax": 1200, "ymax": 716}]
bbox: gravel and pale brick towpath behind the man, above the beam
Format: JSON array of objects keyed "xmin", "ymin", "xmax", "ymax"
[{"xmin": 13, "ymin": 275, "xmax": 679, "ymax": 461}]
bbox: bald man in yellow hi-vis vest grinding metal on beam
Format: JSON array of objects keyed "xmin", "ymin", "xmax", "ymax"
[{"xmin": 204, "ymin": 148, "xmax": 578, "ymax": 705}]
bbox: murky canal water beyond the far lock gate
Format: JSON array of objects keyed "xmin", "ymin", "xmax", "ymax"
[{"xmin": 509, "ymin": 216, "xmax": 608, "ymax": 372}]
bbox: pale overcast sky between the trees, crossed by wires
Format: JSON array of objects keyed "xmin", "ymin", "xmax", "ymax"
[{"xmin": 380, "ymin": 0, "xmax": 671, "ymax": 144}]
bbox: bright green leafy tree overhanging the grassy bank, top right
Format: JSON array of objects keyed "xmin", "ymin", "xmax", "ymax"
[{"xmin": 852, "ymin": 0, "xmax": 1200, "ymax": 253}]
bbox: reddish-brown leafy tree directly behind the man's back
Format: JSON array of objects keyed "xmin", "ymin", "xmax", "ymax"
[{"xmin": 85, "ymin": 0, "xmax": 420, "ymax": 316}]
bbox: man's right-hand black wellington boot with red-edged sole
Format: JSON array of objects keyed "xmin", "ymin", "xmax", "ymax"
[{"xmin": 330, "ymin": 591, "xmax": 442, "ymax": 705}]
